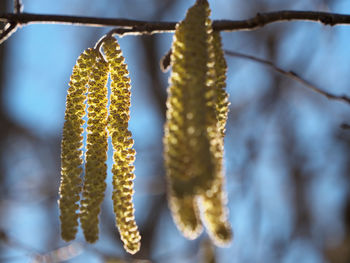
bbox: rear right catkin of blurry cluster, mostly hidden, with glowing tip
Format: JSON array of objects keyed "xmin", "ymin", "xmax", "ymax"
[{"xmin": 201, "ymin": 32, "xmax": 232, "ymax": 246}]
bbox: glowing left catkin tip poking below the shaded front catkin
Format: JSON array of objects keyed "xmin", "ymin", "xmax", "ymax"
[{"xmin": 168, "ymin": 194, "xmax": 203, "ymax": 239}]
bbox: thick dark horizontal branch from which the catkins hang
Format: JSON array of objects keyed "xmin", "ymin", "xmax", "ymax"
[{"xmin": 0, "ymin": 9, "xmax": 350, "ymax": 41}]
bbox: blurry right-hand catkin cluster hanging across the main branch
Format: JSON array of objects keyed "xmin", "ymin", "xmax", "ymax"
[{"xmin": 164, "ymin": 0, "xmax": 232, "ymax": 248}]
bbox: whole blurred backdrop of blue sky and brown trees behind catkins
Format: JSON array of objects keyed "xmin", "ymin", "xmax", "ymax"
[{"xmin": 0, "ymin": 0, "xmax": 350, "ymax": 263}]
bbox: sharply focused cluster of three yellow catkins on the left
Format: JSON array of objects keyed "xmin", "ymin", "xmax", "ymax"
[{"xmin": 59, "ymin": 36, "xmax": 141, "ymax": 254}]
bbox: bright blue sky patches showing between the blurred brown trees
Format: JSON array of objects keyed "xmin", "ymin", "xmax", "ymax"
[{"xmin": 0, "ymin": 0, "xmax": 350, "ymax": 263}]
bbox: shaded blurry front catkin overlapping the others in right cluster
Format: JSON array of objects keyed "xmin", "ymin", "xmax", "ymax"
[{"xmin": 164, "ymin": 1, "xmax": 217, "ymax": 200}]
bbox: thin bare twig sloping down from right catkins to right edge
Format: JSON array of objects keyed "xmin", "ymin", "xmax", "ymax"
[{"xmin": 225, "ymin": 50, "xmax": 350, "ymax": 104}]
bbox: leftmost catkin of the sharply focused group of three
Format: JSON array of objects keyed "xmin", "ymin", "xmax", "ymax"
[{"xmin": 59, "ymin": 49, "xmax": 96, "ymax": 241}]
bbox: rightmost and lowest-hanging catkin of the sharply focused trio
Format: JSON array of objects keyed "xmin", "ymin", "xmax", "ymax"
[{"xmin": 103, "ymin": 37, "xmax": 141, "ymax": 254}]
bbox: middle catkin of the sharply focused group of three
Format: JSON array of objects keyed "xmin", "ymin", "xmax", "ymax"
[{"xmin": 80, "ymin": 50, "xmax": 108, "ymax": 243}]
